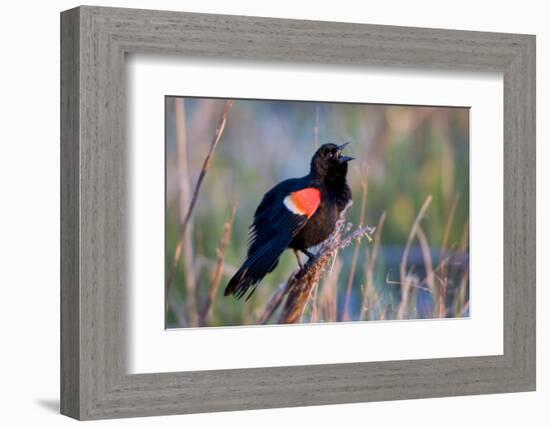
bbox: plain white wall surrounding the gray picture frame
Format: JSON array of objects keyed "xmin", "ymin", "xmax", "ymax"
[{"xmin": 0, "ymin": 0, "xmax": 550, "ymax": 427}]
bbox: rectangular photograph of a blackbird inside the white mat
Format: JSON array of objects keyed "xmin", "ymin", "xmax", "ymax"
[{"xmin": 165, "ymin": 96, "xmax": 470, "ymax": 329}]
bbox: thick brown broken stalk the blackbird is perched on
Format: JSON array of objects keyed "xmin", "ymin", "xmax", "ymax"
[{"xmin": 279, "ymin": 204, "xmax": 374, "ymax": 323}]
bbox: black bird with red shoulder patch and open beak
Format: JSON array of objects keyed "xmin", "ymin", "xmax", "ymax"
[{"xmin": 225, "ymin": 143, "xmax": 353, "ymax": 299}]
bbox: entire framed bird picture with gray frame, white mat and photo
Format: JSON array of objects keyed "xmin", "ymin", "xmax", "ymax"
[{"xmin": 61, "ymin": 6, "xmax": 535, "ymax": 419}]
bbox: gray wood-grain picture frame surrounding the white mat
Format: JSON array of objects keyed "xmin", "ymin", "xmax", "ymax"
[{"xmin": 61, "ymin": 6, "xmax": 535, "ymax": 419}]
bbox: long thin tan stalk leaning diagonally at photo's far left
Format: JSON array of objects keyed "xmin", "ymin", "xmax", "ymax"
[{"xmin": 165, "ymin": 100, "xmax": 234, "ymax": 320}]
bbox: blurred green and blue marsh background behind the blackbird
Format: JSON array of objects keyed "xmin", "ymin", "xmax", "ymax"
[{"xmin": 166, "ymin": 97, "xmax": 469, "ymax": 328}]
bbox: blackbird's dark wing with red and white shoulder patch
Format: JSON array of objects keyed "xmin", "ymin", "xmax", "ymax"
[{"xmin": 225, "ymin": 181, "xmax": 321, "ymax": 298}]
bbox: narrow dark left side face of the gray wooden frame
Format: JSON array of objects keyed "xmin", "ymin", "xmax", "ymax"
[{"xmin": 60, "ymin": 10, "xmax": 80, "ymax": 417}]
